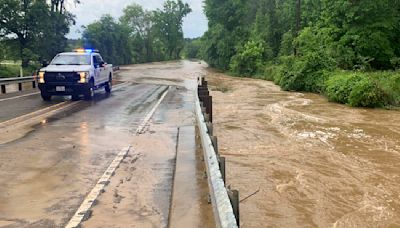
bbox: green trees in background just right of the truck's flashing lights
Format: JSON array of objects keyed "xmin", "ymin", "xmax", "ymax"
[{"xmin": 83, "ymin": 0, "xmax": 191, "ymax": 64}]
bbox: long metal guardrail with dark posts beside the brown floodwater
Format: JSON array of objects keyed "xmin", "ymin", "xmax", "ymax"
[{"xmin": 195, "ymin": 79, "xmax": 240, "ymax": 228}]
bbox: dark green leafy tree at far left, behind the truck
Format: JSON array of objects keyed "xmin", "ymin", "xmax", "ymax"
[{"xmin": 0, "ymin": 0, "xmax": 73, "ymax": 67}]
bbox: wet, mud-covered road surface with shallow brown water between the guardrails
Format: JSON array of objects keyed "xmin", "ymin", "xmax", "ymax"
[{"xmin": 0, "ymin": 61, "xmax": 212, "ymax": 228}]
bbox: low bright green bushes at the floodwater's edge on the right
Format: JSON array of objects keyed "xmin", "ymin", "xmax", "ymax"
[{"xmin": 254, "ymin": 65, "xmax": 400, "ymax": 108}]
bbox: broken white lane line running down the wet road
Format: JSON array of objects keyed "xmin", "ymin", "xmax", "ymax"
[{"xmin": 65, "ymin": 84, "xmax": 170, "ymax": 228}]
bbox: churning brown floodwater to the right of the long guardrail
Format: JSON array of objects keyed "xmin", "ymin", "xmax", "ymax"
[{"xmin": 208, "ymin": 70, "xmax": 400, "ymax": 227}]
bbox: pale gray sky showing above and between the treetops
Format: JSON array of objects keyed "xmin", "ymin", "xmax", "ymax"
[{"xmin": 67, "ymin": 0, "xmax": 207, "ymax": 38}]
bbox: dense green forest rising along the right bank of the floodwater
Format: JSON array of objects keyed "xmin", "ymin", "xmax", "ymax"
[{"xmin": 196, "ymin": 0, "xmax": 400, "ymax": 107}]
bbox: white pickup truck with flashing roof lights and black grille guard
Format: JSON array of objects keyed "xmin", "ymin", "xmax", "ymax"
[{"xmin": 37, "ymin": 49, "xmax": 113, "ymax": 101}]
